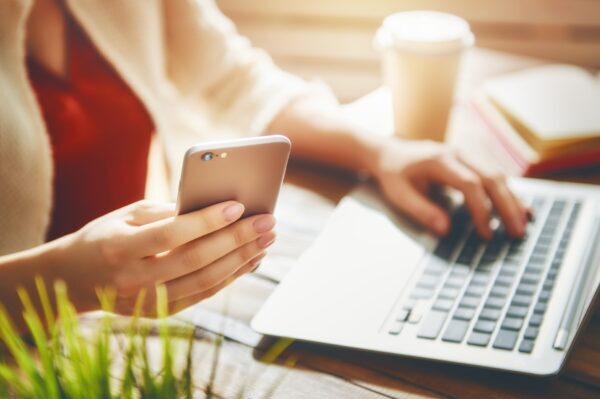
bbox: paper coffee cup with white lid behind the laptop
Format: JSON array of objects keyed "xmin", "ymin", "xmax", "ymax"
[{"xmin": 374, "ymin": 11, "xmax": 474, "ymax": 141}]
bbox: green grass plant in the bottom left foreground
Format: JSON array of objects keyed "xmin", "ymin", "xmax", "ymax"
[{"xmin": 0, "ymin": 278, "xmax": 193, "ymax": 399}]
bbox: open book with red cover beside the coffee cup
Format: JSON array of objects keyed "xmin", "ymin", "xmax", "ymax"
[{"xmin": 473, "ymin": 65, "xmax": 600, "ymax": 176}]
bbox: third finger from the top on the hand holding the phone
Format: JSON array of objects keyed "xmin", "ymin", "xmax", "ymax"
[{"xmin": 165, "ymin": 236, "xmax": 275, "ymax": 301}]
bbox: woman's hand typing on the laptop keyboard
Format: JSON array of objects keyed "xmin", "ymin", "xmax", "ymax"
[{"xmin": 370, "ymin": 138, "xmax": 529, "ymax": 239}]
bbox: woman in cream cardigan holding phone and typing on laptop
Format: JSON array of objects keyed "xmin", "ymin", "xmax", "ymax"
[{"xmin": 0, "ymin": 0, "xmax": 527, "ymax": 328}]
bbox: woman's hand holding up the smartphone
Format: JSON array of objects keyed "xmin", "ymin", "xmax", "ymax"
[{"xmin": 58, "ymin": 201, "xmax": 275, "ymax": 314}]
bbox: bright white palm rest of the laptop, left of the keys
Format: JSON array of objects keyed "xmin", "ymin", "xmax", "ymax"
[{"xmin": 252, "ymin": 190, "xmax": 427, "ymax": 345}]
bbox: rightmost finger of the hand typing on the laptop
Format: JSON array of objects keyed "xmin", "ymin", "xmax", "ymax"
[{"xmin": 461, "ymin": 158, "xmax": 529, "ymax": 237}]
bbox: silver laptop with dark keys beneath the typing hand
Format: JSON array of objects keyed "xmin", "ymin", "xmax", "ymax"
[{"xmin": 252, "ymin": 178, "xmax": 600, "ymax": 376}]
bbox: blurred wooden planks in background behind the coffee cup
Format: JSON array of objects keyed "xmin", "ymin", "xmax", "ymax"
[{"xmin": 217, "ymin": 0, "xmax": 600, "ymax": 101}]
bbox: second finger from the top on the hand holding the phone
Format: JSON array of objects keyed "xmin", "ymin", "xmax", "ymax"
[{"xmin": 146, "ymin": 215, "xmax": 275, "ymax": 282}]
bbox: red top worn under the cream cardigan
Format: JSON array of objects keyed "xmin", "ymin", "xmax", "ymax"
[{"xmin": 27, "ymin": 17, "xmax": 154, "ymax": 240}]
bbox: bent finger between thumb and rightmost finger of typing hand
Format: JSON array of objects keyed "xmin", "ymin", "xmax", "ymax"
[{"xmin": 431, "ymin": 158, "xmax": 492, "ymax": 239}]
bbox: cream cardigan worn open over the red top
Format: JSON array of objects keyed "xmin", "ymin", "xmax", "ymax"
[{"xmin": 0, "ymin": 0, "xmax": 316, "ymax": 255}]
